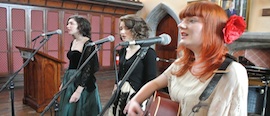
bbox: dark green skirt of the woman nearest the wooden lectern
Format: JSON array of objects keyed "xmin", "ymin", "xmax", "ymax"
[{"xmin": 58, "ymin": 69, "xmax": 101, "ymax": 116}]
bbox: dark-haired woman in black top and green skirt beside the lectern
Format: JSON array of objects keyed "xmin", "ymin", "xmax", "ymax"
[{"xmin": 59, "ymin": 15, "xmax": 101, "ymax": 116}]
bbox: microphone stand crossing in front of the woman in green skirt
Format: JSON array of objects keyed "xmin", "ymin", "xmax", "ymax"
[{"xmin": 40, "ymin": 44, "xmax": 102, "ymax": 116}]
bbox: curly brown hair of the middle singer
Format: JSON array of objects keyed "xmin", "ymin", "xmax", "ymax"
[{"xmin": 120, "ymin": 14, "xmax": 150, "ymax": 40}]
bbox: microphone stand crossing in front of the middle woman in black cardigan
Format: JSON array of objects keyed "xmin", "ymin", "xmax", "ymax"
[{"xmin": 99, "ymin": 47, "xmax": 149, "ymax": 116}]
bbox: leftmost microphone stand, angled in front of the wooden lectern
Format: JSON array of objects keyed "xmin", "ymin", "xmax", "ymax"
[{"xmin": 0, "ymin": 36, "xmax": 51, "ymax": 116}]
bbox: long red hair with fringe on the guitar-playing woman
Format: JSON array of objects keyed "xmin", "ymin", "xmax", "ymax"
[{"xmin": 173, "ymin": 1, "xmax": 228, "ymax": 78}]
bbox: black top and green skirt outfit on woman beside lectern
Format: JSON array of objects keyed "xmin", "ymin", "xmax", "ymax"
[{"xmin": 59, "ymin": 40, "xmax": 101, "ymax": 116}]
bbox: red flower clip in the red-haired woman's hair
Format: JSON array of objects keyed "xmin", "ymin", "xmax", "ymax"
[{"xmin": 222, "ymin": 15, "xmax": 246, "ymax": 44}]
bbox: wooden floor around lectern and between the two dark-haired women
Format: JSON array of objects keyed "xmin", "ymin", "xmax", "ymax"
[{"xmin": 0, "ymin": 71, "xmax": 115, "ymax": 116}]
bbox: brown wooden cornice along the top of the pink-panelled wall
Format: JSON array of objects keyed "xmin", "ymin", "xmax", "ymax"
[{"xmin": 4, "ymin": 0, "xmax": 142, "ymax": 15}]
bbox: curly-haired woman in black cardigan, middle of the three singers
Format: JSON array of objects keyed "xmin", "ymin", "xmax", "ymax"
[{"xmin": 109, "ymin": 15, "xmax": 157, "ymax": 116}]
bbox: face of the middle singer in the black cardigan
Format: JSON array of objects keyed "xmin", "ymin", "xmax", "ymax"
[{"xmin": 119, "ymin": 21, "xmax": 134, "ymax": 42}]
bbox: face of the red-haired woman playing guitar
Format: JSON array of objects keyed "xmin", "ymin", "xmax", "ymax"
[{"xmin": 178, "ymin": 16, "xmax": 203, "ymax": 50}]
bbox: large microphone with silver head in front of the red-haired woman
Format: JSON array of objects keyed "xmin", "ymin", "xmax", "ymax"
[{"xmin": 119, "ymin": 34, "xmax": 171, "ymax": 46}]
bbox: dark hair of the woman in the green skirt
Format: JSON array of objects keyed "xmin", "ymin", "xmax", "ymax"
[{"xmin": 68, "ymin": 15, "xmax": 91, "ymax": 39}]
